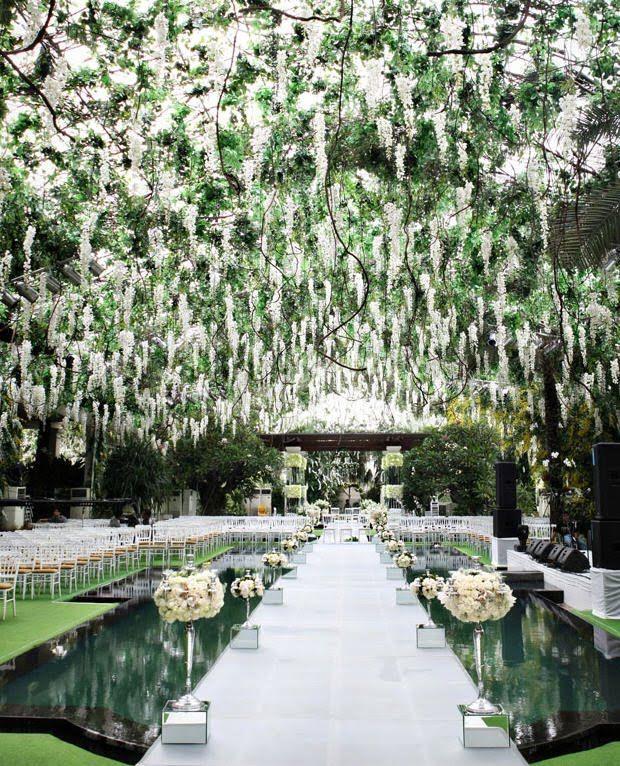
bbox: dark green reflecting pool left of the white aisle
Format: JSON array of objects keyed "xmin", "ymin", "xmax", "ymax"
[{"xmin": 0, "ymin": 554, "xmax": 276, "ymax": 744}]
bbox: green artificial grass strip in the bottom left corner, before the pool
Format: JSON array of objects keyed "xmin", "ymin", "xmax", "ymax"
[{"xmin": 0, "ymin": 734, "xmax": 120, "ymax": 766}]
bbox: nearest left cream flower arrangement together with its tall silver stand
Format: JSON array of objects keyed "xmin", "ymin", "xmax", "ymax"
[{"xmin": 153, "ymin": 561, "xmax": 225, "ymax": 710}]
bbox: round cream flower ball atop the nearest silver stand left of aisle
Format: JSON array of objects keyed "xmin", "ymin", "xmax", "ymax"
[{"xmin": 153, "ymin": 569, "xmax": 224, "ymax": 622}]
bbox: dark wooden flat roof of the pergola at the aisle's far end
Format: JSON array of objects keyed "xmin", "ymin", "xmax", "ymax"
[{"xmin": 260, "ymin": 432, "xmax": 426, "ymax": 452}]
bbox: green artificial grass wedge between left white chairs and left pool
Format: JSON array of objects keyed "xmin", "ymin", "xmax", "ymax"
[{"xmin": 0, "ymin": 598, "xmax": 116, "ymax": 664}]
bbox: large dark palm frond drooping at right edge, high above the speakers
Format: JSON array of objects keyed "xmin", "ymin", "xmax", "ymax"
[{"xmin": 551, "ymin": 178, "xmax": 620, "ymax": 268}]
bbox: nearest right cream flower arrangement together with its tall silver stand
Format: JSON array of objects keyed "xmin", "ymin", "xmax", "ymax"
[{"xmin": 438, "ymin": 569, "xmax": 516, "ymax": 715}]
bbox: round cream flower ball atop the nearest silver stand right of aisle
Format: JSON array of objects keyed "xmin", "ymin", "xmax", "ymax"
[{"xmin": 438, "ymin": 569, "xmax": 516, "ymax": 623}]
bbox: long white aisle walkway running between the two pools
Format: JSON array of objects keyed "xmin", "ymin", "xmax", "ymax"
[{"xmin": 141, "ymin": 543, "xmax": 525, "ymax": 766}]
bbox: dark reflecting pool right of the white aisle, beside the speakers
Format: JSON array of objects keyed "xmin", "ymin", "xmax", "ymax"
[{"xmin": 433, "ymin": 584, "xmax": 620, "ymax": 754}]
